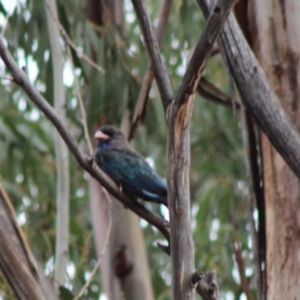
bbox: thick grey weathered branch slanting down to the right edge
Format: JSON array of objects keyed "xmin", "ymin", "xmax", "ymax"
[{"xmin": 197, "ymin": 0, "xmax": 300, "ymax": 178}]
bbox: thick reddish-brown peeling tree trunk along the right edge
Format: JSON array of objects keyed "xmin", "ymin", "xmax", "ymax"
[{"xmin": 251, "ymin": 0, "xmax": 300, "ymax": 300}]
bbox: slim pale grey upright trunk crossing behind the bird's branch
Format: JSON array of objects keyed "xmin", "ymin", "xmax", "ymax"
[{"xmin": 45, "ymin": 0, "xmax": 70, "ymax": 285}]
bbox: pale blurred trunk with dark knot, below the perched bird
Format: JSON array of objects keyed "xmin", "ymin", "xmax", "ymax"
[{"xmin": 90, "ymin": 179, "xmax": 154, "ymax": 300}]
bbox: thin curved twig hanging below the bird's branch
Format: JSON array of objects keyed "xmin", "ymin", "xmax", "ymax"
[{"xmin": 73, "ymin": 188, "xmax": 112, "ymax": 300}]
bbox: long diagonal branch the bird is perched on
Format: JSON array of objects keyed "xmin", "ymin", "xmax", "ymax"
[{"xmin": 0, "ymin": 38, "xmax": 169, "ymax": 241}]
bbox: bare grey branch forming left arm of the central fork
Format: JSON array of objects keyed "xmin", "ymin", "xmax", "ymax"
[{"xmin": 132, "ymin": 0, "xmax": 173, "ymax": 111}]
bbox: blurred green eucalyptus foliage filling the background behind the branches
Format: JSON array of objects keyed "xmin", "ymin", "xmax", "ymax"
[{"xmin": 0, "ymin": 0, "xmax": 253, "ymax": 299}]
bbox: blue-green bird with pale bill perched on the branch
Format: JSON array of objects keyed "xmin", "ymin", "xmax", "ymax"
[{"xmin": 94, "ymin": 125, "xmax": 168, "ymax": 206}]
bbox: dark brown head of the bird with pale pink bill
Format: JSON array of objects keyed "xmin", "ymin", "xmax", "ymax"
[{"xmin": 94, "ymin": 125, "xmax": 126, "ymax": 149}]
